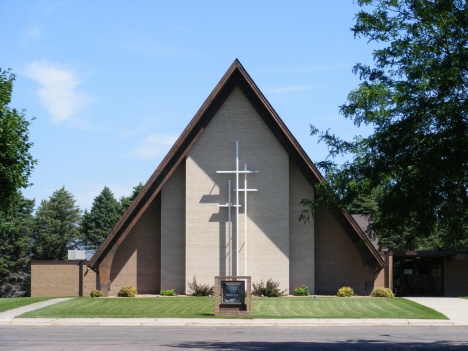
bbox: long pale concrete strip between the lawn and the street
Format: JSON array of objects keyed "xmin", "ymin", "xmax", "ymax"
[{"xmin": 0, "ymin": 318, "xmax": 460, "ymax": 327}]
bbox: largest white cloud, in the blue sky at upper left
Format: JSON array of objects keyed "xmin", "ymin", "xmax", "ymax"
[{"xmin": 24, "ymin": 61, "xmax": 91, "ymax": 123}]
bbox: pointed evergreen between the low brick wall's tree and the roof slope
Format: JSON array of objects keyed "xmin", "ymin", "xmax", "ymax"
[{"xmin": 82, "ymin": 187, "xmax": 121, "ymax": 247}]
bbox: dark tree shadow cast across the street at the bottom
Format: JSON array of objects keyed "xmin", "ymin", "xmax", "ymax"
[{"xmin": 163, "ymin": 339, "xmax": 468, "ymax": 351}]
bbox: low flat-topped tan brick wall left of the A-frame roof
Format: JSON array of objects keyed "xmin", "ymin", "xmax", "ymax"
[{"xmin": 31, "ymin": 261, "xmax": 80, "ymax": 297}]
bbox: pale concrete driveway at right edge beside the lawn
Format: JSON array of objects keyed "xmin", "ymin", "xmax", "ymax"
[{"xmin": 406, "ymin": 297, "xmax": 468, "ymax": 325}]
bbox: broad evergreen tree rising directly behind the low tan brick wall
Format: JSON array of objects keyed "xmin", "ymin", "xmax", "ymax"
[{"xmin": 33, "ymin": 187, "xmax": 81, "ymax": 260}]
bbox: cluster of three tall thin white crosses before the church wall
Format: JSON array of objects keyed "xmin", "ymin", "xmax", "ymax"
[{"xmin": 216, "ymin": 141, "xmax": 258, "ymax": 275}]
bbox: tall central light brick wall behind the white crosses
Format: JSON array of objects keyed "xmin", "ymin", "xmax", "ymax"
[{"xmin": 186, "ymin": 88, "xmax": 289, "ymax": 296}]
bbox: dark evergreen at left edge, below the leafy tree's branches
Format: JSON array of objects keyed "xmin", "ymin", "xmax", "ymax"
[{"xmin": 0, "ymin": 191, "xmax": 34, "ymax": 297}]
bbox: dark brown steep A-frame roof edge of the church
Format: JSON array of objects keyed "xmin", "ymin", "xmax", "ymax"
[{"xmin": 89, "ymin": 59, "xmax": 386, "ymax": 269}]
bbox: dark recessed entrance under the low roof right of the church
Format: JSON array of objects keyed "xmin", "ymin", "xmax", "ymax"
[{"xmin": 393, "ymin": 257, "xmax": 444, "ymax": 296}]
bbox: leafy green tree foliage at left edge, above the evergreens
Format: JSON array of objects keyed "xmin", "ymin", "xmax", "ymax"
[{"xmin": 0, "ymin": 69, "xmax": 37, "ymax": 210}]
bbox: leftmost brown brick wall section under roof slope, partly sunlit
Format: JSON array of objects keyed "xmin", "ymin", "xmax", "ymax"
[{"xmin": 109, "ymin": 194, "xmax": 161, "ymax": 296}]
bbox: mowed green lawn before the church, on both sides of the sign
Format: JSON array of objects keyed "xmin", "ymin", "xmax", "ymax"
[{"xmin": 21, "ymin": 297, "xmax": 447, "ymax": 319}]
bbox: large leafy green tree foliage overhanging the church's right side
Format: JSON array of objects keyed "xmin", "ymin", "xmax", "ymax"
[{"xmin": 303, "ymin": 0, "xmax": 468, "ymax": 249}]
